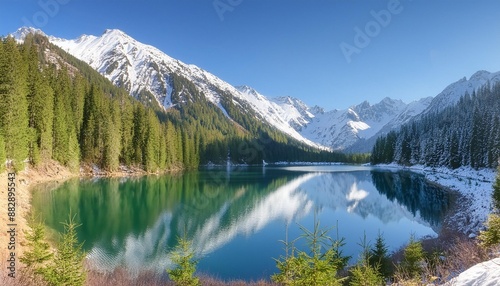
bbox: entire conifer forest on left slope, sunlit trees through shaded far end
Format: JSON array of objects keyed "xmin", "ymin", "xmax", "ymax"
[{"xmin": 0, "ymin": 35, "xmax": 367, "ymax": 172}]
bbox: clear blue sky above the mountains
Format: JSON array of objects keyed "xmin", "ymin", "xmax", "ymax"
[{"xmin": 0, "ymin": 0, "xmax": 500, "ymax": 110}]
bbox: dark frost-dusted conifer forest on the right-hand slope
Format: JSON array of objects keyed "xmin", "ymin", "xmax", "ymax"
[{"xmin": 371, "ymin": 83, "xmax": 500, "ymax": 169}]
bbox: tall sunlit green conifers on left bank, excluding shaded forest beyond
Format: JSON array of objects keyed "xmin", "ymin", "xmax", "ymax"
[{"xmin": 0, "ymin": 33, "xmax": 191, "ymax": 171}]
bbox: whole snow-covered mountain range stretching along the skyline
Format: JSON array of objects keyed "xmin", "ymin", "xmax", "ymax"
[{"xmin": 12, "ymin": 27, "xmax": 500, "ymax": 152}]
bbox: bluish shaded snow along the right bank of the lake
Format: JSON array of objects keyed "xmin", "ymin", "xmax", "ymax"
[{"xmin": 377, "ymin": 164, "xmax": 496, "ymax": 237}]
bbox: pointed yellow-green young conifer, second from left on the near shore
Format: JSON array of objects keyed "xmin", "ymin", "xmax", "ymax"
[{"xmin": 45, "ymin": 215, "xmax": 86, "ymax": 286}]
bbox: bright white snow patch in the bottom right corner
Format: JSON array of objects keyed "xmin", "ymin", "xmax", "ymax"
[{"xmin": 445, "ymin": 258, "xmax": 500, "ymax": 286}]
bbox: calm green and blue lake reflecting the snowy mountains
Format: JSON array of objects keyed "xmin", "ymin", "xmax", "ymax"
[{"xmin": 32, "ymin": 165, "xmax": 453, "ymax": 280}]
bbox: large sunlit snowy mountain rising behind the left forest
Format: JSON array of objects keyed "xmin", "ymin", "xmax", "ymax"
[{"xmin": 38, "ymin": 27, "xmax": 325, "ymax": 149}]
